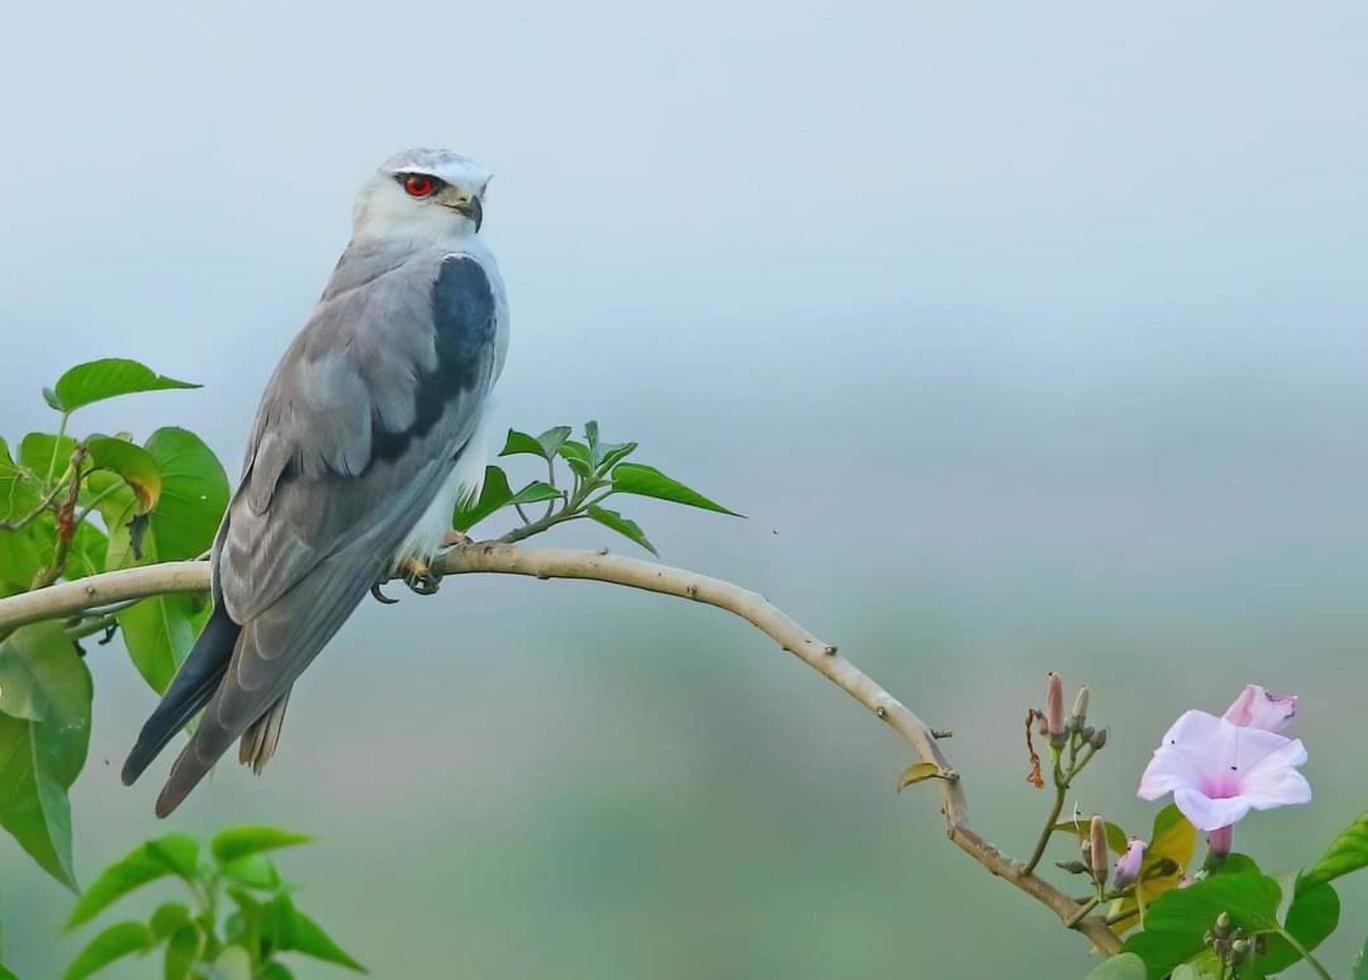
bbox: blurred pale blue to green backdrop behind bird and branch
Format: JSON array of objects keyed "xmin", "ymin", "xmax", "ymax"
[{"xmin": 0, "ymin": 0, "xmax": 1368, "ymax": 980}]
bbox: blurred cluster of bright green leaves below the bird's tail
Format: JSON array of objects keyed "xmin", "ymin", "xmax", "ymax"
[{"xmin": 64, "ymin": 827, "xmax": 365, "ymax": 980}]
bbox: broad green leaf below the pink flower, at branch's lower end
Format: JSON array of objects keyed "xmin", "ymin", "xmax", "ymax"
[{"xmin": 1123, "ymin": 875, "xmax": 1282, "ymax": 980}]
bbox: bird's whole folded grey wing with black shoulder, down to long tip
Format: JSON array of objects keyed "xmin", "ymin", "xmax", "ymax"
[{"xmin": 157, "ymin": 252, "xmax": 497, "ymax": 813}]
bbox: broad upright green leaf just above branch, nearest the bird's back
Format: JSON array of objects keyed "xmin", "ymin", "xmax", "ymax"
[{"xmin": 146, "ymin": 427, "xmax": 228, "ymax": 561}]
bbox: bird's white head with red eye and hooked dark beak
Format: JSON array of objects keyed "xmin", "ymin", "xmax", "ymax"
[{"xmin": 352, "ymin": 149, "xmax": 492, "ymax": 241}]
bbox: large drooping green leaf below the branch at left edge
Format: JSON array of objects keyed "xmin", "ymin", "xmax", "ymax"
[{"xmin": 0, "ymin": 623, "xmax": 90, "ymax": 890}]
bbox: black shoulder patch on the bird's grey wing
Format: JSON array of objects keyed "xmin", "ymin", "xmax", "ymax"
[{"xmin": 371, "ymin": 255, "xmax": 494, "ymax": 464}]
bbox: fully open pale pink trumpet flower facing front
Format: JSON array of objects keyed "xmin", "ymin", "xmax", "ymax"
[{"xmin": 1140, "ymin": 712, "xmax": 1311, "ymax": 831}]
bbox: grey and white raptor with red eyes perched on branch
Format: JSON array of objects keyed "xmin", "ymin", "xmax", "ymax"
[{"xmin": 122, "ymin": 149, "xmax": 509, "ymax": 817}]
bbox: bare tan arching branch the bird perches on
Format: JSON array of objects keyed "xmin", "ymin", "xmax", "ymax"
[{"xmin": 0, "ymin": 542, "xmax": 1120, "ymax": 954}]
